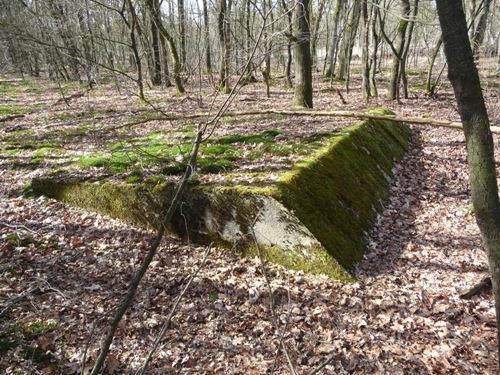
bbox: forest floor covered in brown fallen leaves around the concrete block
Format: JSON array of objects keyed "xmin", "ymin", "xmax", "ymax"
[{"xmin": 0, "ymin": 63, "xmax": 500, "ymax": 374}]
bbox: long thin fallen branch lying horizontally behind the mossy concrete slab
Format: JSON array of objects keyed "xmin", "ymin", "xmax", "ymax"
[{"xmin": 106, "ymin": 109, "xmax": 500, "ymax": 134}]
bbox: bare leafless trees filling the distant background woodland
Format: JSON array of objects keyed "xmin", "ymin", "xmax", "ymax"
[{"xmin": 0, "ymin": 0, "xmax": 500, "ymax": 106}]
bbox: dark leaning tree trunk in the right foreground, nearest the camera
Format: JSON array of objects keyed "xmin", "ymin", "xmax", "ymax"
[{"xmin": 436, "ymin": 0, "xmax": 500, "ymax": 358}]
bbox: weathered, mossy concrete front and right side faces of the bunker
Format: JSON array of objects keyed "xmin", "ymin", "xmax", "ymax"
[{"xmin": 32, "ymin": 114, "xmax": 409, "ymax": 280}]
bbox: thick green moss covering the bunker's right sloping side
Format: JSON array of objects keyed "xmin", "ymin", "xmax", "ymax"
[{"xmin": 276, "ymin": 117, "xmax": 409, "ymax": 270}]
